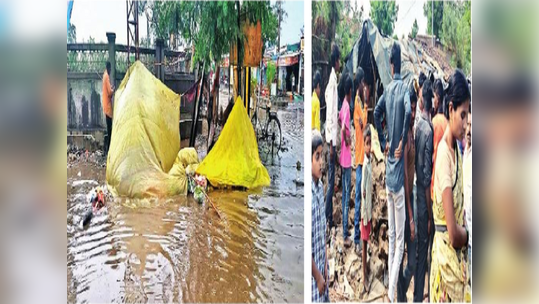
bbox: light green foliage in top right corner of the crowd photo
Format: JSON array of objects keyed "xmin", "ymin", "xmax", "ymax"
[{"xmin": 441, "ymin": 1, "xmax": 471, "ymax": 74}]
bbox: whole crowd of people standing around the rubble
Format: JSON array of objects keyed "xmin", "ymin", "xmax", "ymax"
[{"xmin": 311, "ymin": 42, "xmax": 472, "ymax": 302}]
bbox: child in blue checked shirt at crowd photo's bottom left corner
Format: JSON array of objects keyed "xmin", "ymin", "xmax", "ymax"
[{"xmin": 311, "ymin": 129, "xmax": 329, "ymax": 302}]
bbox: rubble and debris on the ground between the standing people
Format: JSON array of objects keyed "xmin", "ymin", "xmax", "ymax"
[{"xmin": 322, "ymin": 126, "xmax": 389, "ymax": 302}]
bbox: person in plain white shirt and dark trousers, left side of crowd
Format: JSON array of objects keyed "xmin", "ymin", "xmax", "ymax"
[{"xmin": 325, "ymin": 44, "xmax": 341, "ymax": 230}]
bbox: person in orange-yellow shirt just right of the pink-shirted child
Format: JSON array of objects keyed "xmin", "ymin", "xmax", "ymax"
[{"xmin": 354, "ymin": 67, "xmax": 367, "ymax": 254}]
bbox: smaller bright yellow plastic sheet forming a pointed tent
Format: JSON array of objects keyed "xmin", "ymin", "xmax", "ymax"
[{"xmin": 196, "ymin": 97, "xmax": 270, "ymax": 189}]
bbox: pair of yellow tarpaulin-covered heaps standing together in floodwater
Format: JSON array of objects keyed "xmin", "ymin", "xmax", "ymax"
[{"xmin": 106, "ymin": 61, "xmax": 270, "ymax": 198}]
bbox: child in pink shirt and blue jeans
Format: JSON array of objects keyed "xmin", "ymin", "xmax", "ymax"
[{"xmin": 339, "ymin": 74, "xmax": 353, "ymax": 247}]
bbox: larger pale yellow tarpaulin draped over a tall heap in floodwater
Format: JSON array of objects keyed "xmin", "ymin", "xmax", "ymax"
[{"xmin": 107, "ymin": 61, "xmax": 198, "ymax": 198}]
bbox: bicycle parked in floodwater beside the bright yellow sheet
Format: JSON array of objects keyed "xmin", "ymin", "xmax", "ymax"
[{"xmin": 251, "ymin": 99, "xmax": 283, "ymax": 157}]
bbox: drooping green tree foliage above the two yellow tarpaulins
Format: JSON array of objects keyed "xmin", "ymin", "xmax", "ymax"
[{"xmin": 151, "ymin": 1, "xmax": 277, "ymax": 65}]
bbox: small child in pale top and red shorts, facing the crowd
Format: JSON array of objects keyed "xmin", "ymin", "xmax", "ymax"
[{"xmin": 361, "ymin": 125, "xmax": 372, "ymax": 292}]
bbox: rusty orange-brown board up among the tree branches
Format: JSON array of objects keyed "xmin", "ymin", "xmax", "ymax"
[{"xmin": 230, "ymin": 21, "xmax": 262, "ymax": 67}]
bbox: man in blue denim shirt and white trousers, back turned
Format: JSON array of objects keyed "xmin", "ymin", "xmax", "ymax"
[{"xmin": 374, "ymin": 42, "xmax": 411, "ymax": 302}]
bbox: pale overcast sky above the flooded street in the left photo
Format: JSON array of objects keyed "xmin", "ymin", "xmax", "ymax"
[{"xmin": 71, "ymin": 0, "xmax": 304, "ymax": 45}]
